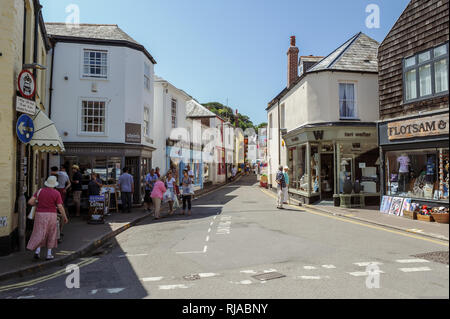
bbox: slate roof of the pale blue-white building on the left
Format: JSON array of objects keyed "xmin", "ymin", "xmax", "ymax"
[{"xmin": 45, "ymin": 22, "xmax": 156, "ymax": 64}]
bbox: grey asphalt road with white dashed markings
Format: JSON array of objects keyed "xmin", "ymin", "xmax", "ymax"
[{"xmin": 0, "ymin": 177, "xmax": 449, "ymax": 299}]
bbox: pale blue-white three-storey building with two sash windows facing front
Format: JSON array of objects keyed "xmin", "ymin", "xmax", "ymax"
[{"xmin": 46, "ymin": 23, "xmax": 157, "ymax": 204}]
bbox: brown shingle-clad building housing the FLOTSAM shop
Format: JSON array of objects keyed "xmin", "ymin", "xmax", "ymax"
[{"xmin": 378, "ymin": 0, "xmax": 449, "ymax": 207}]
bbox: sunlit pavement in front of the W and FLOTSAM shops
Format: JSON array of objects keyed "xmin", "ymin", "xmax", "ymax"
[{"xmin": 269, "ymin": 189, "xmax": 449, "ymax": 241}]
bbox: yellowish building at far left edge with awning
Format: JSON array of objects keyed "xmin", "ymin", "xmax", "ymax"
[{"xmin": 0, "ymin": 0, "xmax": 64, "ymax": 255}]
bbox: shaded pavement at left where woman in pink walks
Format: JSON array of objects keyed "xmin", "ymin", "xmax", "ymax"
[{"xmin": 0, "ymin": 176, "xmax": 240, "ymax": 281}]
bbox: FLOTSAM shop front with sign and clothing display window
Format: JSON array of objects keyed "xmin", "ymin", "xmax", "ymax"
[{"xmin": 378, "ymin": 110, "xmax": 449, "ymax": 207}]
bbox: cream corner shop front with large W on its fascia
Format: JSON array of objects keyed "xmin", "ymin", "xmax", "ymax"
[{"xmin": 283, "ymin": 123, "xmax": 380, "ymax": 204}]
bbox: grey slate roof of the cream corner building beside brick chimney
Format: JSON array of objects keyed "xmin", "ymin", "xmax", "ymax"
[{"xmin": 308, "ymin": 32, "xmax": 380, "ymax": 72}]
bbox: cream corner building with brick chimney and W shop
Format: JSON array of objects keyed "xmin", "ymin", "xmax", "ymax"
[{"xmin": 266, "ymin": 33, "xmax": 379, "ymax": 203}]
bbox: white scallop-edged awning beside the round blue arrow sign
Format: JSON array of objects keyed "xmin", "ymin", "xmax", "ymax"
[{"xmin": 30, "ymin": 110, "xmax": 66, "ymax": 153}]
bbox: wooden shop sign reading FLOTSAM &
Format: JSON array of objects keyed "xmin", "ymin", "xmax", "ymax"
[{"xmin": 388, "ymin": 114, "xmax": 449, "ymax": 140}]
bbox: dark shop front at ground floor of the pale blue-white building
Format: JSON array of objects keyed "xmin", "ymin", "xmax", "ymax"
[{"xmin": 60, "ymin": 143, "xmax": 154, "ymax": 212}]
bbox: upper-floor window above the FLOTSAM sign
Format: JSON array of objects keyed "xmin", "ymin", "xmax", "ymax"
[{"xmin": 403, "ymin": 43, "xmax": 448, "ymax": 102}]
